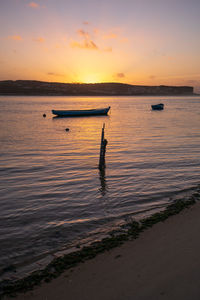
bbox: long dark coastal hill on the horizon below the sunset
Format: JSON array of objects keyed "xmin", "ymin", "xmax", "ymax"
[{"xmin": 0, "ymin": 80, "xmax": 194, "ymax": 96}]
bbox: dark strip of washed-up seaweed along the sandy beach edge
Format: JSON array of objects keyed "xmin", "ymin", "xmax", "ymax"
[{"xmin": 0, "ymin": 191, "xmax": 200, "ymax": 299}]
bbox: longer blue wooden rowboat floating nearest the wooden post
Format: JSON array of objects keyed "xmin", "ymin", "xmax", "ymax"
[{"xmin": 52, "ymin": 106, "xmax": 110, "ymax": 117}]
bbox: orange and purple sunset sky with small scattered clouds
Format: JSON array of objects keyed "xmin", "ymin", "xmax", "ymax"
[{"xmin": 0, "ymin": 0, "xmax": 200, "ymax": 89}]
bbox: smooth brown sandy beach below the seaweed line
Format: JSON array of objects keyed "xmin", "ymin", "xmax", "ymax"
[{"xmin": 6, "ymin": 199, "xmax": 200, "ymax": 300}]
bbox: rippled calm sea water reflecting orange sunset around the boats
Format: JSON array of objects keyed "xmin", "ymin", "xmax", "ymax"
[{"xmin": 0, "ymin": 96, "xmax": 200, "ymax": 278}]
